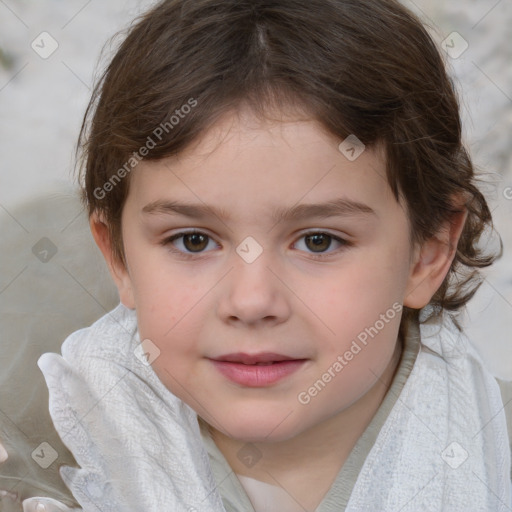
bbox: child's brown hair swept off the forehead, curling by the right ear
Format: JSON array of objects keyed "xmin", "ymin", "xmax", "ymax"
[{"xmin": 79, "ymin": 0, "xmax": 495, "ymax": 320}]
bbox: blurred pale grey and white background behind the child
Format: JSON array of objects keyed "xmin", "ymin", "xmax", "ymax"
[{"xmin": 0, "ymin": 0, "xmax": 512, "ymax": 382}]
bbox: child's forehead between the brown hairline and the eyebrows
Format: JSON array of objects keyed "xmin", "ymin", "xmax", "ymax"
[{"xmin": 127, "ymin": 112, "xmax": 398, "ymax": 221}]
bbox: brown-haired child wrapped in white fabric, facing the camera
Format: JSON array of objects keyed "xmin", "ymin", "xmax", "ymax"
[{"xmin": 7, "ymin": 0, "xmax": 511, "ymax": 512}]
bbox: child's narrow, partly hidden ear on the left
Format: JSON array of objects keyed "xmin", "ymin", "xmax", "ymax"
[{"xmin": 89, "ymin": 212, "xmax": 135, "ymax": 309}]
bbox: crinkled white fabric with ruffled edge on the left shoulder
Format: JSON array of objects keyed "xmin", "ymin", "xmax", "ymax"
[{"xmin": 38, "ymin": 305, "xmax": 224, "ymax": 512}]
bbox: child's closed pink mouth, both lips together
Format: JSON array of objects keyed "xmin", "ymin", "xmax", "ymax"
[{"xmin": 210, "ymin": 352, "xmax": 307, "ymax": 387}]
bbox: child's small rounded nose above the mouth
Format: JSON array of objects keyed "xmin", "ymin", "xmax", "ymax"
[{"xmin": 217, "ymin": 250, "xmax": 291, "ymax": 327}]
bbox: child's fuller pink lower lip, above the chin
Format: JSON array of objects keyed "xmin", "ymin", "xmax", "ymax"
[{"xmin": 212, "ymin": 359, "xmax": 306, "ymax": 388}]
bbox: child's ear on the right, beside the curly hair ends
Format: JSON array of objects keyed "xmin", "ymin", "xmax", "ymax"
[{"xmin": 404, "ymin": 206, "xmax": 467, "ymax": 309}]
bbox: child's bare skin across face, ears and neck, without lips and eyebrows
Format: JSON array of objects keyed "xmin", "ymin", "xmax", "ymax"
[{"xmin": 91, "ymin": 109, "xmax": 465, "ymax": 510}]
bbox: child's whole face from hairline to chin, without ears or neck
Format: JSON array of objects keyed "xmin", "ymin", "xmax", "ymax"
[{"xmin": 118, "ymin": 108, "xmax": 420, "ymax": 441}]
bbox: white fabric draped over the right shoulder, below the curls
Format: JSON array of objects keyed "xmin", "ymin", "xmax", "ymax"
[{"xmin": 346, "ymin": 311, "xmax": 512, "ymax": 512}]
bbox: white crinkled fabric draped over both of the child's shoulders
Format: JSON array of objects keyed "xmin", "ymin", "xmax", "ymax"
[{"xmin": 38, "ymin": 305, "xmax": 511, "ymax": 512}]
